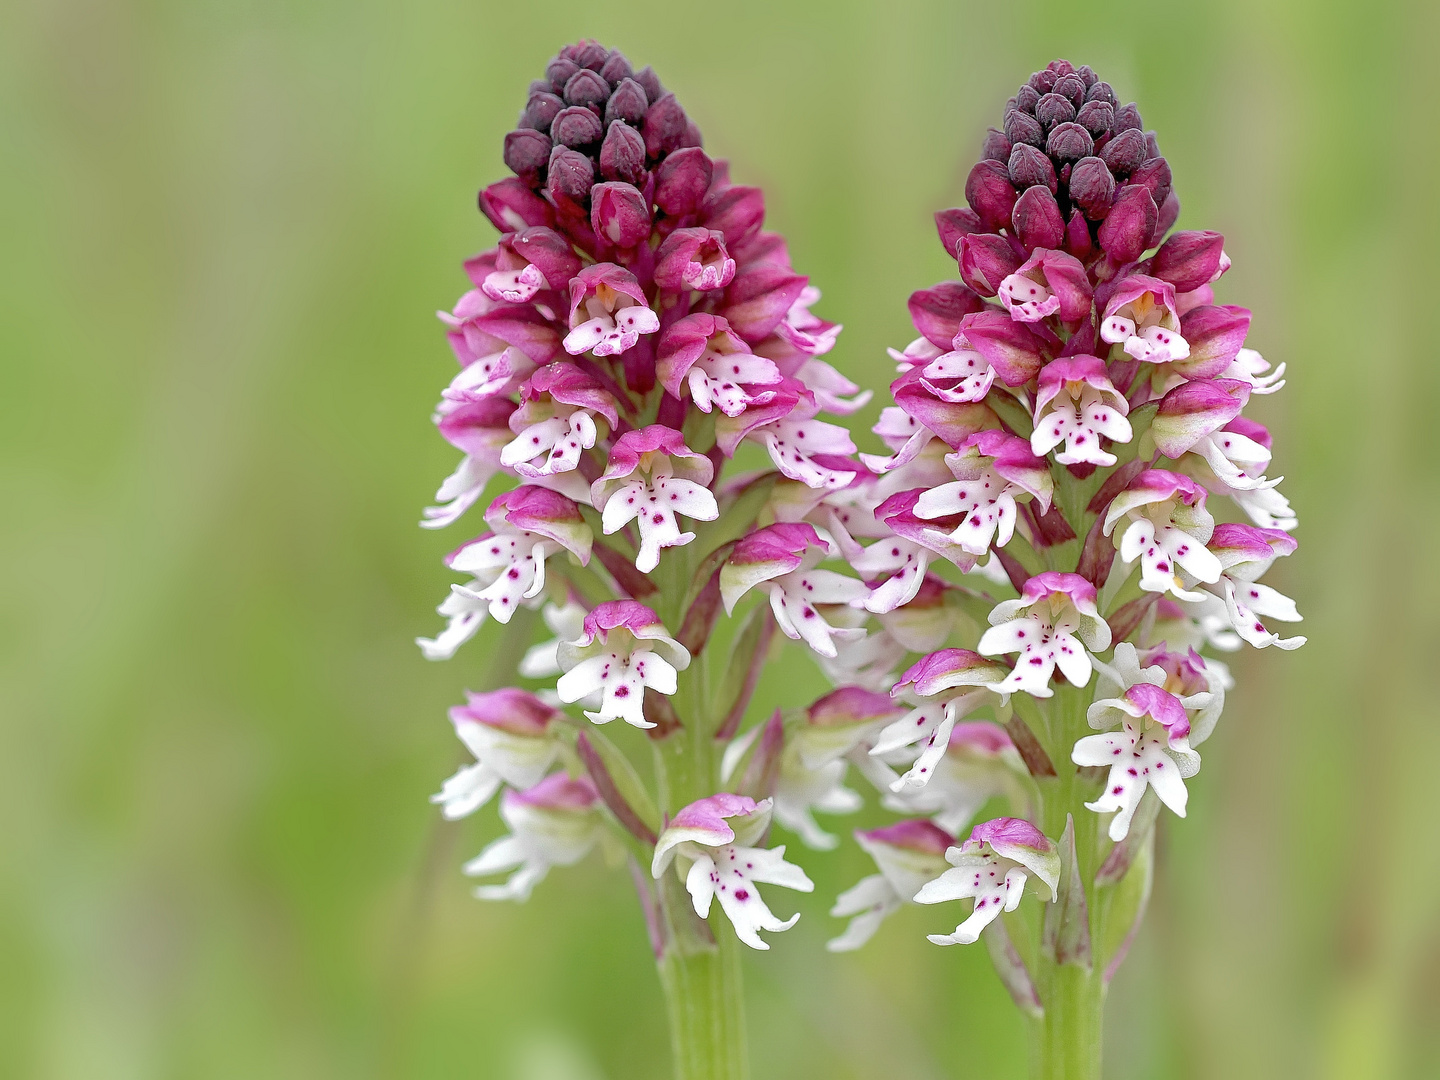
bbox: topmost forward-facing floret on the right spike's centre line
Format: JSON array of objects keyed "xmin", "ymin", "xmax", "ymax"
[{"xmin": 1030, "ymin": 356, "xmax": 1132, "ymax": 465}]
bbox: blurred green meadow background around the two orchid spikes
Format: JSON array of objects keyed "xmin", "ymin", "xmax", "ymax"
[{"xmin": 0, "ymin": 0, "xmax": 1440, "ymax": 1080}]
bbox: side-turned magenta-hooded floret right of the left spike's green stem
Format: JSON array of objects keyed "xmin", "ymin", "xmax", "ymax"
[{"xmin": 720, "ymin": 523, "xmax": 870, "ymax": 657}]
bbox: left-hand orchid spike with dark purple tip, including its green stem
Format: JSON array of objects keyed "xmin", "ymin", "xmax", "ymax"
[{"xmin": 419, "ymin": 42, "xmax": 869, "ymax": 1079}]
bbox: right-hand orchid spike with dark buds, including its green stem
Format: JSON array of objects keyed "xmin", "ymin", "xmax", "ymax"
[{"xmin": 812, "ymin": 60, "xmax": 1303, "ymax": 1080}]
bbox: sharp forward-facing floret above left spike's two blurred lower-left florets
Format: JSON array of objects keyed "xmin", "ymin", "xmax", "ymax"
[{"xmin": 556, "ymin": 600, "xmax": 690, "ymax": 727}]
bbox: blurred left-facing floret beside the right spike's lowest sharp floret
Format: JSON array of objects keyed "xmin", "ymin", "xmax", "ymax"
[{"xmin": 825, "ymin": 819, "xmax": 955, "ymax": 952}]
